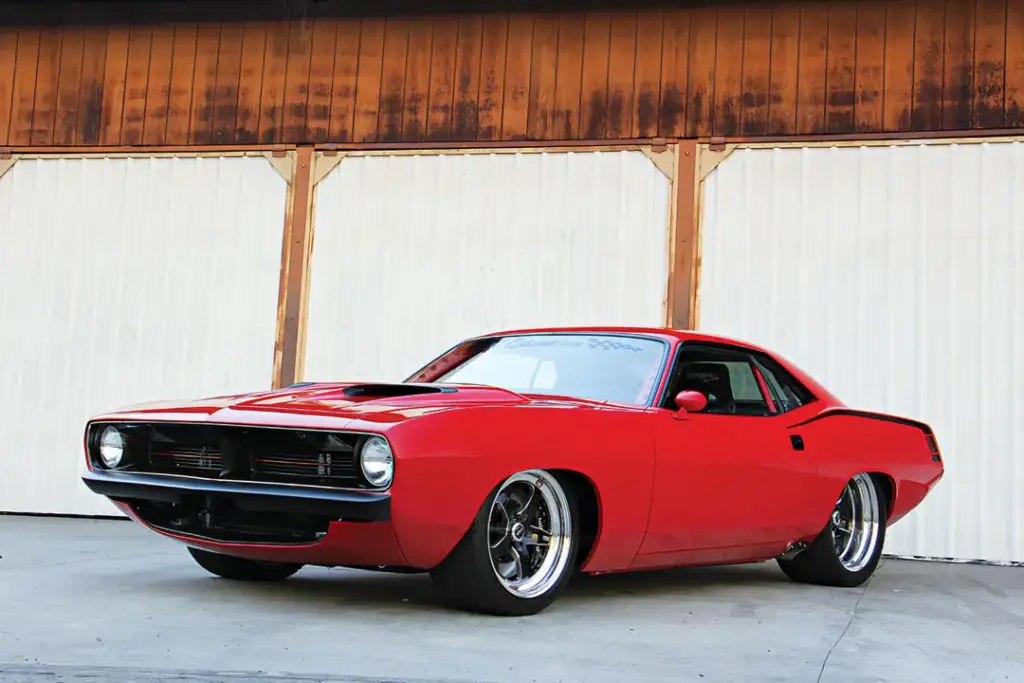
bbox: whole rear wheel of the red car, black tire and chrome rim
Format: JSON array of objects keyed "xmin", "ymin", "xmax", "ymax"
[{"xmin": 778, "ymin": 473, "xmax": 888, "ymax": 587}]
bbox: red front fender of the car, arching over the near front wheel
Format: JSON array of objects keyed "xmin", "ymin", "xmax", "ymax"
[{"xmin": 388, "ymin": 405, "xmax": 654, "ymax": 571}]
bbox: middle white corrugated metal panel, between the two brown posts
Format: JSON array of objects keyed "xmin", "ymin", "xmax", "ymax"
[{"xmin": 304, "ymin": 152, "xmax": 670, "ymax": 381}]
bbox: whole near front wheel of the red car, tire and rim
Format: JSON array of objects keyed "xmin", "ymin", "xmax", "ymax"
[{"xmin": 430, "ymin": 470, "xmax": 580, "ymax": 616}]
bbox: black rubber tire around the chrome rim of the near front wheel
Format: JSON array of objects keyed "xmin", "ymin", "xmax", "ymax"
[{"xmin": 430, "ymin": 470, "xmax": 580, "ymax": 616}]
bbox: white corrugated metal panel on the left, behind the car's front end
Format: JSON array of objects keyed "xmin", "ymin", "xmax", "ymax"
[{"xmin": 0, "ymin": 158, "xmax": 286, "ymax": 514}]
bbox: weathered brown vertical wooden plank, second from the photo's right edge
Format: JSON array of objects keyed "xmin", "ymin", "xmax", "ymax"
[{"xmin": 971, "ymin": 0, "xmax": 1007, "ymax": 128}]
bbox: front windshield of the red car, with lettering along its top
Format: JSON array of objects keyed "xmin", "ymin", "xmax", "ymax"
[{"xmin": 432, "ymin": 334, "xmax": 668, "ymax": 405}]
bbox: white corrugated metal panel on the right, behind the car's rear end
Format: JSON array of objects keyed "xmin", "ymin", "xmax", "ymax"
[{"xmin": 699, "ymin": 142, "xmax": 1024, "ymax": 561}]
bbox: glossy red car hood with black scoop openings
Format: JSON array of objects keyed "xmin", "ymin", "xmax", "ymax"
[{"xmin": 94, "ymin": 383, "xmax": 600, "ymax": 429}]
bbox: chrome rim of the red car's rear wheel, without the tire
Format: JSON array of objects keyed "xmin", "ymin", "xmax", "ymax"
[{"xmin": 829, "ymin": 474, "xmax": 882, "ymax": 571}]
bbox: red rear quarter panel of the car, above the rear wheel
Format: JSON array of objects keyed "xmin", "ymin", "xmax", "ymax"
[{"xmin": 791, "ymin": 409, "xmax": 943, "ymax": 529}]
